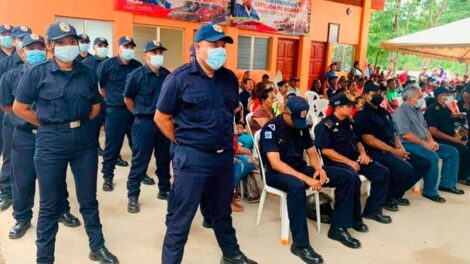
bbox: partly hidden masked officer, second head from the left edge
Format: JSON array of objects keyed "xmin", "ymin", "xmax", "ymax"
[{"xmin": 0, "ymin": 23, "xmax": 31, "ymax": 211}]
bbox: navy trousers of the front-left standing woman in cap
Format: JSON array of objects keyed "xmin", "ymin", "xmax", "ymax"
[{"xmin": 34, "ymin": 122, "xmax": 104, "ymax": 264}]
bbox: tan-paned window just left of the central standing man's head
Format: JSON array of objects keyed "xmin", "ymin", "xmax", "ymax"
[{"xmin": 134, "ymin": 25, "xmax": 184, "ymax": 69}]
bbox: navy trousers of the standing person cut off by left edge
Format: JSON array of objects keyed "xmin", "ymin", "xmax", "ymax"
[{"xmin": 0, "ymin": 114, "xmax": 15, "ymax": 199}]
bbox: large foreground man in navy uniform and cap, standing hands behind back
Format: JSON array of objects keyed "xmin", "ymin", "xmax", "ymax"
[{"xmin": 155, "ymin": 24, "xmax": 256, "ymax": 264}]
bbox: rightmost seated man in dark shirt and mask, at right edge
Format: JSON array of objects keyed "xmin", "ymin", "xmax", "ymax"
[{"xmin": 424, "ymin": 87, "xmax": 470, "ymax": 186}]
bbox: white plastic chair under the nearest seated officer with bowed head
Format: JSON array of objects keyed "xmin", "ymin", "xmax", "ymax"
[{"xmin": 254, "ymin": 131, "xmax": 321, "ymax": 245}]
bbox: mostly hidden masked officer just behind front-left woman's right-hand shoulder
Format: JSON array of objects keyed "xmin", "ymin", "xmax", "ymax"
[{"xmin": 82, "ymin": 37, "xmax": 110, "ymax": 157}]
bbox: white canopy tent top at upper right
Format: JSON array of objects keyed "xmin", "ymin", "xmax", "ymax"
[{"xmin": 380, "ymin": 17, "xmax": 470, "ymax": 63}]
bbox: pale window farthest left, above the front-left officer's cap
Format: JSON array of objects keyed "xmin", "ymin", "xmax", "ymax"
[{"xmin": 56, "ymin": 17, "xmax": 113, "ymax": 57}]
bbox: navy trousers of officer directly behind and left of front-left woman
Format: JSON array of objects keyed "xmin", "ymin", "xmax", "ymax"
[{"xmin": 11, "ymin": 127, "xmax": 70, "ymax": 222}]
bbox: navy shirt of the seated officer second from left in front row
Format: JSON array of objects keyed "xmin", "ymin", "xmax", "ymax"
[{"xmin": 315, "ymin": 114, "xmax": 359, "ymax": 164}]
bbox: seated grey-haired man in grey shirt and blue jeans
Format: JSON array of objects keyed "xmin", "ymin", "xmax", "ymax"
[{"xmin": 393, "ymin": 84, "xmax": 464, "ymax": 203}]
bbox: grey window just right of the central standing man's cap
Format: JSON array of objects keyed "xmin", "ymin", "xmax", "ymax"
[{"xmin": 237, "ymin": 36, "xmax": 269, "ymax": 70}]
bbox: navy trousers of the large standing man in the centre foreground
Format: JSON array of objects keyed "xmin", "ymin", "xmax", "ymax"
[{"xmin": 162, "ymin": 145, "xmax": 240, "ymax": 264}]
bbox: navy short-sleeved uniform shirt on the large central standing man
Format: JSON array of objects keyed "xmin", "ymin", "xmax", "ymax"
[{"xmin": 157, "ymin": 60, "xmax": 238, "ymax": 151}]
